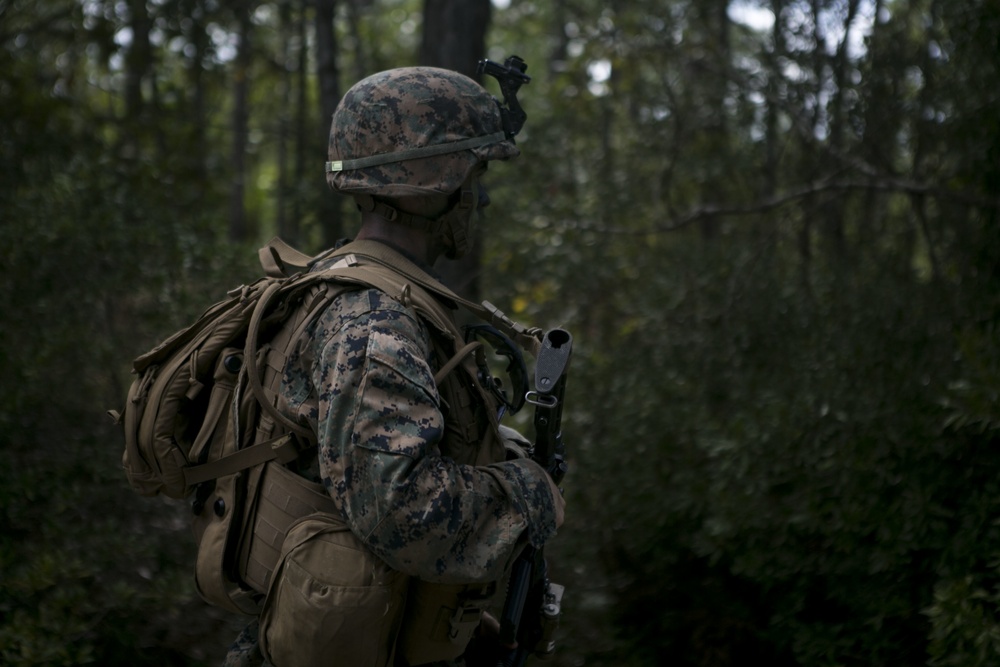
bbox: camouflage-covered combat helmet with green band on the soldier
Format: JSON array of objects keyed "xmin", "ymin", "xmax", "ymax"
[{"xmin": 326, "ymin": 67, "xmax": 519, "ymax": 198}]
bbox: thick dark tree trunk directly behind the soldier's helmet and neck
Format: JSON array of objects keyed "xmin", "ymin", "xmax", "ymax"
[{"xmin": 420, "ymin": 0, "xmax": 491, "ymax": 302}]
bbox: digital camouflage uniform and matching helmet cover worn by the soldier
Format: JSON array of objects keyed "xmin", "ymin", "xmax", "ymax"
[{"xmin": 225, "ymin": 68, "xmax": 556, "ymax": 667}]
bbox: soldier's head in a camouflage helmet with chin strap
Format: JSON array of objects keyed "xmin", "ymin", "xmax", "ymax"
[{"xmin": 326, "ymin": 67, "xmax": 519, "ymax": 258}]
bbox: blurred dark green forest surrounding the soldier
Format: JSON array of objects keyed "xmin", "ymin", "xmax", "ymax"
[{"xmin": 0, "ymin": 0, "xmax": 1000, "ymax": 667}]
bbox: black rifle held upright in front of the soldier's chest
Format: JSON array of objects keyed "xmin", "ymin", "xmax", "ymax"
[{"xmin": 498, "ymin": 329, "xmax": 573, "ymax": 667}]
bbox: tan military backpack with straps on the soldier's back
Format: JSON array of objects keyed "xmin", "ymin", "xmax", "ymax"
[{"xmin": 110, "ymin": 248, "xmax": 376, "ymax": 614}]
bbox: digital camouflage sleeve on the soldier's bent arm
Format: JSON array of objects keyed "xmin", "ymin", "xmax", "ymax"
[{"xmin": 304, "ymin": 291, "xmax": 555, "ymax": 583}]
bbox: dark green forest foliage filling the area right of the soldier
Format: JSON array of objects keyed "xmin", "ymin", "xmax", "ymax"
[{"xmin": 487, "ymin": 2, "xmax": 1000, "ymax": 665}]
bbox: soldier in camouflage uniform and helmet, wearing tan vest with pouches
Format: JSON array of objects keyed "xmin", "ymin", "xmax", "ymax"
[{"xmin": 225, "ymin": 67, "xmax": 564, "ymax": 667}]
